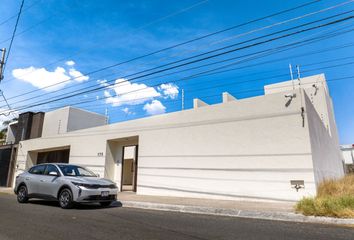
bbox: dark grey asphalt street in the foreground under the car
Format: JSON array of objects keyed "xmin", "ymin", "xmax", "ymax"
[{"xmin": 0, "ymin": 193, "xmax": 354, "ymax": 240}]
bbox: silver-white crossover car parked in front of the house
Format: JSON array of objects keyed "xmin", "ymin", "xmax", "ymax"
[{"xmin": 14, "ymin": 163, "xmax": 118, "ymax": 208}]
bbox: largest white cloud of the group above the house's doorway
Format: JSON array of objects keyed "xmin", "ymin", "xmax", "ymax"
[{"xmin": 103, "ymin": 79, "xmax": 161, "ymax": 106}]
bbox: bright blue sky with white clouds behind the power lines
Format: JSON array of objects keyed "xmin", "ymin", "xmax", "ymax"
[{"xmin": 0, "ymin": 0, "xmax": 354, "ymax": 144}]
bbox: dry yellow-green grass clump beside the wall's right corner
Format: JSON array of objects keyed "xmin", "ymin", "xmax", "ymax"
[{"xmin": 296, "ymin": 174, "xmax": 354, "ymax": 218}]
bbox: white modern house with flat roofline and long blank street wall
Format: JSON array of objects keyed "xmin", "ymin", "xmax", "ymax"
[{"xmin": 12, "ymin": 74, "xmax": 344, "ymax": 201}]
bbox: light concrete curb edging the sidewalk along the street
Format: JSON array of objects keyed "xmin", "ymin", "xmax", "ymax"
[{"xmin": 120, "ymin": 201, "xmax": 354, "ymax": 225}]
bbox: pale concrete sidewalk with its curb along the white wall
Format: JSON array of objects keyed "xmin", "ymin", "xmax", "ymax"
[{"xmin": 118, "ymin": 192, "xmax": 354, "ymax": 226}]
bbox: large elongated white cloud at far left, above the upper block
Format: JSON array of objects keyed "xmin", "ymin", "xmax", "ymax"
[{"xmin": 12, "ymin": 66, "xmax": 70, "ymax": 91}]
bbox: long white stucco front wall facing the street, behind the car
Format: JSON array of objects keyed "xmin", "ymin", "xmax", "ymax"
[{"xmin": 18, "ymin": 87, "xmax": 315, "ymax": 200}]
